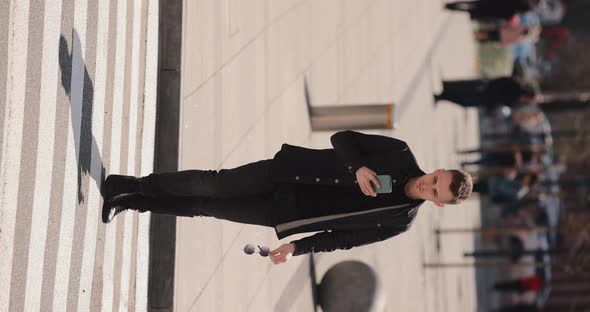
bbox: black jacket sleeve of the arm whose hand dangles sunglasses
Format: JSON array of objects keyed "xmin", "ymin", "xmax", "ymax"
[{"xmin": 291, "ymin": 227, "xmax": 403, "ymax": 256}]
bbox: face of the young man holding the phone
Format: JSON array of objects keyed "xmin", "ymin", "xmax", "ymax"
[{"xmin": 408, "ymin": 169, "xmax": 454, "ymax": 207}]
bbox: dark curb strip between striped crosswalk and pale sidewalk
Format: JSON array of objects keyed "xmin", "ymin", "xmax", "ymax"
[{"xmin": 148, "ymin": 0, "xmax": 183, "ymax": 312}]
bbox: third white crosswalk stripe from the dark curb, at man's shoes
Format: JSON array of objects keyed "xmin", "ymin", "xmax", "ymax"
[{"xmin": 102, "ymin": 1, "xmax": 127, "ymax": 312}]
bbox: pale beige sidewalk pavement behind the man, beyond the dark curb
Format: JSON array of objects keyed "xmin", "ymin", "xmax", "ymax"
[{"xmin": 174, "ymin": 0, "xmax": 479, "ymax": 312}]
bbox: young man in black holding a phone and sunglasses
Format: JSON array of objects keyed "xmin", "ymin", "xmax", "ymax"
[{"xmin": 102, "ymin": 131, "xmax": 472, "ymax": 264}]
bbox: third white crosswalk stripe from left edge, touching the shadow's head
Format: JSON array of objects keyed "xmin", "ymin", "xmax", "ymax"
[{"xmin": 53, "ymin": 0, "xmax": 87, "ymax": 311}]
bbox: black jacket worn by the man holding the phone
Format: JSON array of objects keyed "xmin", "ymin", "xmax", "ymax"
[{"xmin": 271, "ymin": 131, "xmax": 424, "ymax": 255}]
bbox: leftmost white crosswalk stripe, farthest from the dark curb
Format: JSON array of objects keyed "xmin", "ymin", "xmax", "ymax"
[{"xmin": 0, "ymin": 0, "xmax": 29, "ymax": 311}]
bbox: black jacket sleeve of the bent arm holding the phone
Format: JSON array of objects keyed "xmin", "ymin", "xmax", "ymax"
[{"xmin": 330, "ymin": 130, "xmax": 408, "ymax": 175}]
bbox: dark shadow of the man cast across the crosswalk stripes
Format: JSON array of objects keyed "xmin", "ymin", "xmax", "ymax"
[{"xmin": 59, "ymin": 30, "xmax": 105, "ymax": 203}]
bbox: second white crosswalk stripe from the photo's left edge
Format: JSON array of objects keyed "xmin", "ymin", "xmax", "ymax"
[{"xmin": 24, "ymin": 0, "xmax": 62, "ymax": 311}]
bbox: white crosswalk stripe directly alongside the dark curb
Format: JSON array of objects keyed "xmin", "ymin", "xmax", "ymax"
[{"xmin": 135, "ymin": 0, "xmax": 159, "ymax": 311}]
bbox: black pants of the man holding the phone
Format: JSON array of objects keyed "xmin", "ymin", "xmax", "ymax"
[{"xmin": 135, "ymin": 160, "xmax": 277, "ymax": 226}]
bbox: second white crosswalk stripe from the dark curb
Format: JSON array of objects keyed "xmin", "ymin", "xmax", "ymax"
[{"xmin": 119, "ymin": 0, "xmax": 142, "ymax": 311}]
